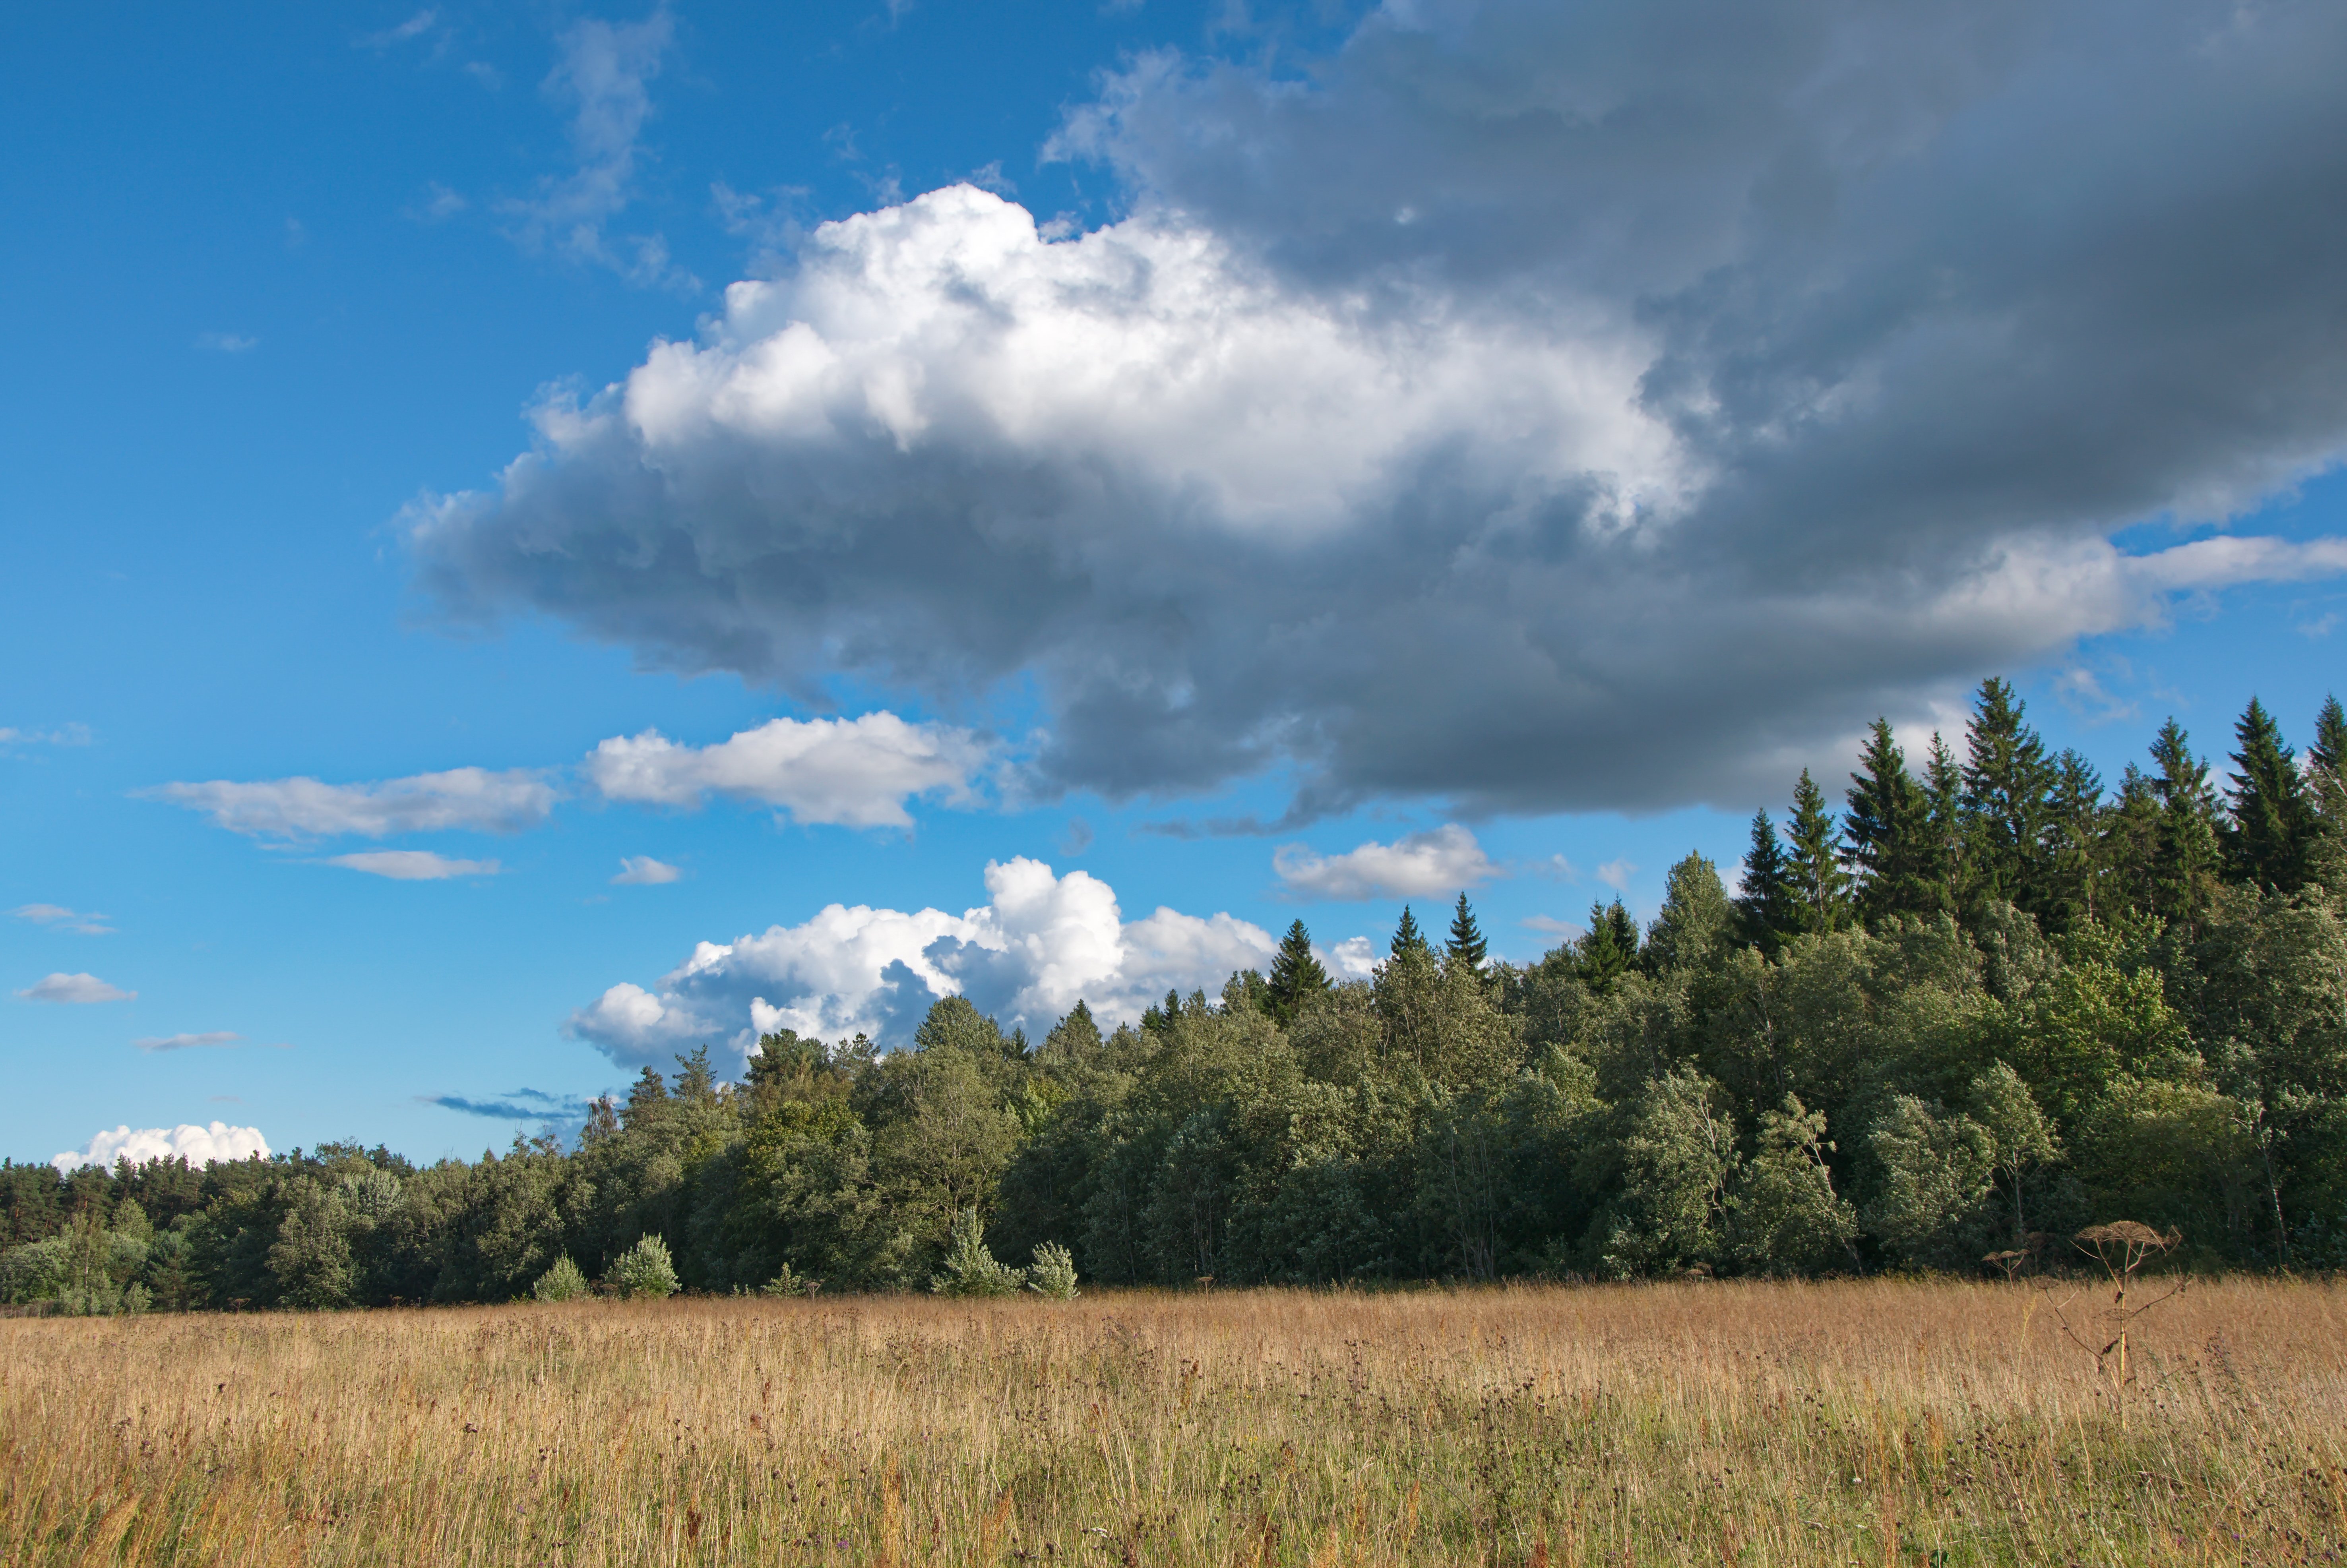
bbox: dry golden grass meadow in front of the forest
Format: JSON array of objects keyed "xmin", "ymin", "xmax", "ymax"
[{"xmin": 0, "ymin": 1282, "xmax": 2347, "ymax": 1566}]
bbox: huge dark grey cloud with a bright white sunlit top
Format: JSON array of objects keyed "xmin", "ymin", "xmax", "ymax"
[{"xmin": 411, "ymin": 0, "xmax": 2347, "ymax": 815}]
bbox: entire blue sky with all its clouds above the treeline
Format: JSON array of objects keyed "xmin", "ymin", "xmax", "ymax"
[{"xmin": 0, "ymin": 0, "xmax": 2347, "ymax": 1162}]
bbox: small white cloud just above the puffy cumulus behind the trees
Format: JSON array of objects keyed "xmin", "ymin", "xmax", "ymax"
[{"xmin": 584, "ymin": 711, "xmax": 986, "ymax": 829}]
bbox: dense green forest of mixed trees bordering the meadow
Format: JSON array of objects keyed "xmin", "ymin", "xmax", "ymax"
[{"xmin": 0, "ymin": 681, "xmax": 2347, "ymax": 1312}]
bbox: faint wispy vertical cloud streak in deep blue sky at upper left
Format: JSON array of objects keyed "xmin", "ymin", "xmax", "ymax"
[{"xmin": 500, "ymin": 5, "xmax": 700, "ymax": 291}]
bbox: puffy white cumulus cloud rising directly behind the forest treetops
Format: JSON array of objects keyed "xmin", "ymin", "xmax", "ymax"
[{"xmin": 566, "ymin": 857, "xmax": 1277, "ymax": 1063}]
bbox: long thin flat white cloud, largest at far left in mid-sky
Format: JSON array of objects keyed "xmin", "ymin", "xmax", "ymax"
[{"xmin": 138, "ymin": 768, "xmax": 556, "ymax": 838}]
